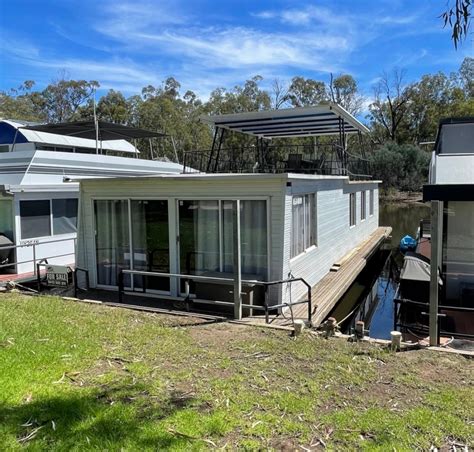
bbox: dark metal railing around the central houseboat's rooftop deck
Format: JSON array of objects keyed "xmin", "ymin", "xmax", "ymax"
[{"xmin": 183, "ymin": 144, "xmax": 372, "ymax": 179}]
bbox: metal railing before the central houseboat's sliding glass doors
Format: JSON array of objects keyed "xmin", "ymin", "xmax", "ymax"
[{"xmin": 117, "ymin": 269, "xmax": 313, "ymax": 323}]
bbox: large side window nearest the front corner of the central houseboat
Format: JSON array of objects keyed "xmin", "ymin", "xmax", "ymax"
[{"xmin": 290, "ymin": 193, "xmax": 318, "ymax": 261}]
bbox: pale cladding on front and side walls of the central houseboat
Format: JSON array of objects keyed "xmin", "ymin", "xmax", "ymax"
[{"xmin": 78, "ymin": 175, "xmax": 379, "ymax": 304}]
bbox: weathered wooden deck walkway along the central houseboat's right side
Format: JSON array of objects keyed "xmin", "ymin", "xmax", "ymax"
[{"xmin": 243, "ymin": 226, "xmax": 392, "ymax": 327}]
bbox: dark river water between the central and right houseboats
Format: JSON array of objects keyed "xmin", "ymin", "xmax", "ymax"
[{"xmin": 330, "ymin": 203, "xmax": 430, "ymax": 339}]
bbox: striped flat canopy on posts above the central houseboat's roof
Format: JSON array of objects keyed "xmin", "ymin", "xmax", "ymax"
[{"xmin": 201, "ymin": 102, "xmax": 369, "ymax": 138}]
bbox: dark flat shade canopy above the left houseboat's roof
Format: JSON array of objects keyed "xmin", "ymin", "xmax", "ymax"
[{"xmin": 22, "ymin": 121, "xmax": 165, "ymax": 141}]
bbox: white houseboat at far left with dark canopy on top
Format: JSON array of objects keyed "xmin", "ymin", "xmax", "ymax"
[{"xmin": 0, "ymin": 120, "xmax": 183, "ymax": 281}]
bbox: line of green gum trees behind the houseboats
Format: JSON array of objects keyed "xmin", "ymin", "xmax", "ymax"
[{"xmin": 0, "ymin": 57, "xmax": 474, "ymax": 190}]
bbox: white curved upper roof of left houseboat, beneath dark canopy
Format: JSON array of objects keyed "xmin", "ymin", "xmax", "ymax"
[{"xmin": 3, "ymin": 119, "xmax": 138, "ymax": 154}]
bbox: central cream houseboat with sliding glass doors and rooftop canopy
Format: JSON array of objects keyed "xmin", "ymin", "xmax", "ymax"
[{"xmin": 77, "ymin": 104, "xmax": 388, "ymax": 318}]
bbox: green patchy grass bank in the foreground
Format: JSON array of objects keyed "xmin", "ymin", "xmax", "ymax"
[{"xmin": 0, "ymin": 294, "xmax": 474, "ymax": 450}]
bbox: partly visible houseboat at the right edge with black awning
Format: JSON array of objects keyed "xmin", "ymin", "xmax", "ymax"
[{"xmin": 395, "ymin": 118, "xmax": 474, "ymax": 345}]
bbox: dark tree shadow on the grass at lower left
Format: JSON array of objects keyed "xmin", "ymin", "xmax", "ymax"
[{"xmin": 0, "ymin": 385, "xmax": 199, "ymax": 449}]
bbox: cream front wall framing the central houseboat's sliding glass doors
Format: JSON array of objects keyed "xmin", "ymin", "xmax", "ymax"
[{"xmin": 78, "ymin": 176, "xmax": 285, "ymax": 294}]
